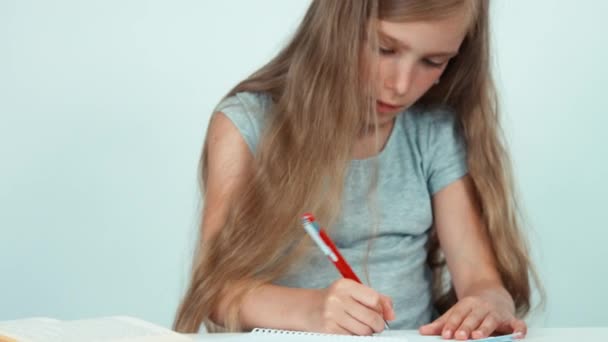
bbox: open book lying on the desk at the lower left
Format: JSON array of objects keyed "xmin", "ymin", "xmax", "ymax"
[{"xmin": 0, "ymin": 316, "xmax": 193, "ymax": 342}]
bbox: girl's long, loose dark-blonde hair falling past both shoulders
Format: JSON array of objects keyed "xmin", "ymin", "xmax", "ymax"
[{"xmin": 174, "ymin": 0, "xmax": 536, "ymax": 332}]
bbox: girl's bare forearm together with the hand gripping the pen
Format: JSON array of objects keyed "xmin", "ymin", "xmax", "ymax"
[{"xmin": 229, "ymin": 279, "xmax": 395, "ymax": 335}]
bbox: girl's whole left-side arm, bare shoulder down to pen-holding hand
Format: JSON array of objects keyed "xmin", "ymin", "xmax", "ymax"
[{"xmin": 201, "ymin": 112, "xmax": 394, "ymax": 335}]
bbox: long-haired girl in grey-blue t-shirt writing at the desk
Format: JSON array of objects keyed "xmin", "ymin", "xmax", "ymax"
[{"xmin": 175, "ymin": 0, "xmax": 534, "ymax": 339}]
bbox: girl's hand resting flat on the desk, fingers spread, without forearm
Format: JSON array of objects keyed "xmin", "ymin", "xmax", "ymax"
[{"xmin": 419, "ymin": 296, "xmax": 528, "ymax": 340}]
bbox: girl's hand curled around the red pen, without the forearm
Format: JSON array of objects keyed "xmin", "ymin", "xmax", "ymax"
[{"xmin": 308, "ymin": 279, "xmax": 395, "ymax": 335}]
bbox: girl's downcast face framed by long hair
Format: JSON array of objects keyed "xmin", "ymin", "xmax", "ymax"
[{"xmin": 371, "ymin": 11, "xmax": 468, "ymax": 125}]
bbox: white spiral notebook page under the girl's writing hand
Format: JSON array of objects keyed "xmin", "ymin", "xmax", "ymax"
[{"xmin": 244, "ymin": 328, "xmax": 407, "ymax": 342}]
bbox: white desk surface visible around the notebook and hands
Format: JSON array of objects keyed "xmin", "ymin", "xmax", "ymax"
[{"xmin": 188, "ymin": 327, "xmax": 608, "ymax": 342}]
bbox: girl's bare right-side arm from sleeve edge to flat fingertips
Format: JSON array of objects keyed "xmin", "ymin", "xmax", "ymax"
[{"xmin": 420, "ymin": 175, "xmax": 526, "ymax": 339}]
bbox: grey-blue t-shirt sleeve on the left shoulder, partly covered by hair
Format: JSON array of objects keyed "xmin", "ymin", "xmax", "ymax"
[{"xmin": 215, "ymin": 93, "xmax": 266, "ymax": 154}]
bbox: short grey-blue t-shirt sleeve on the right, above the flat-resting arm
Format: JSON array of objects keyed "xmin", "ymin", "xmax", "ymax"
[{"xmin": 423, "ymin": 110, "xmax": 468, "ymax": 195}]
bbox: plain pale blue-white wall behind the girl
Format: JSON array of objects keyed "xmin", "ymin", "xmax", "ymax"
[{"xmin": 0, "ymin": 0, "xmax": 608, "ymax": 327}]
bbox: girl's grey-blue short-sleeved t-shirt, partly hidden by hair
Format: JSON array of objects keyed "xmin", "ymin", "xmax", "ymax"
[{"xmin": 216, "ymin": 92, "xmax": 467, "ymax": 329}]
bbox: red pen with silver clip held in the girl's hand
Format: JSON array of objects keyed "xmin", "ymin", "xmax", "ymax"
[{"xmin": 302, "ymin": 213, "xmax": 390, "ymax": 329}]
